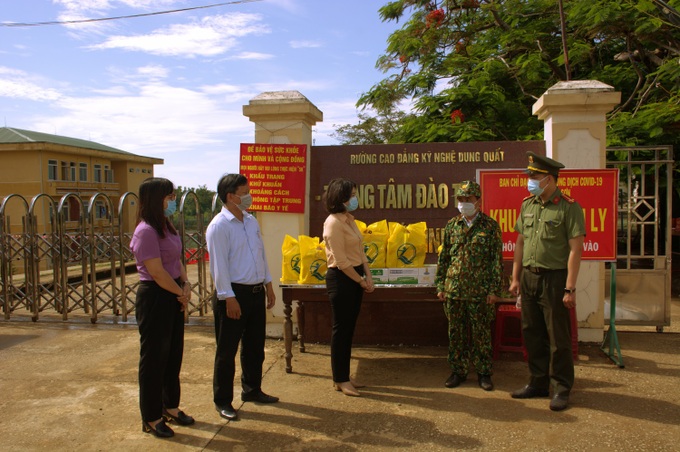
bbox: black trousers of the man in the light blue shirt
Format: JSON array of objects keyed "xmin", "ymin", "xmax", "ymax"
[{"xmin": 212, "ymin": 284, "xmax": 267, "ymax": 406}]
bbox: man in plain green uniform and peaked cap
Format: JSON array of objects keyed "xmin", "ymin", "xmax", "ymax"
[{"xmin": 510, "ymin": 152, "xmax": 586, "ymax": 411}]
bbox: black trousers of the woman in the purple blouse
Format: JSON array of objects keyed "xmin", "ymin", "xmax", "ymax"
[{"xmin": 135, "ymin": 281, "xmax": 184, "ymax": 422}]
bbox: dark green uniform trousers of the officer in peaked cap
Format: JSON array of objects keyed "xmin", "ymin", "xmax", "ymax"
[{"xmin": 520, "ymin": 270, "xmax": 574, "ymax": 395}]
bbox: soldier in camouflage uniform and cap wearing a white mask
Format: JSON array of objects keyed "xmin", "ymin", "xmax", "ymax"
[{"xmin": 435, "ymin": 181, "xmax": 503, "ymax": 391}]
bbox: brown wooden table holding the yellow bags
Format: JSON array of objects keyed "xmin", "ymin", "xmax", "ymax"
[{"xmin": 280, "ymin": 284, "xmax": 441, "ymax": 373}]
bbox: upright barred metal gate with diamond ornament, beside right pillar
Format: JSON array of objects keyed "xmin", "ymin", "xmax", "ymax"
[{"xmin": 604, "ymin": 146, "xmax": 674, "ymax": 331}]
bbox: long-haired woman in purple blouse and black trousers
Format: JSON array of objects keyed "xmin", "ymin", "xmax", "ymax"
[{"xmin": 130, "ymin": 177, "xmax": 194, "ymax": 438}]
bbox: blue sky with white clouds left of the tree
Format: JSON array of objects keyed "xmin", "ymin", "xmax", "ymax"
[{"xmin": 0, "ymin": 0, "xmax": 400, "ymax": 189}]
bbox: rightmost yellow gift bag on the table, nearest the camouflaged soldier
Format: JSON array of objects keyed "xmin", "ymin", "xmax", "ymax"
[{"xmin": 387, "ymin": 221, "xmax": 427, "ymax": 268}]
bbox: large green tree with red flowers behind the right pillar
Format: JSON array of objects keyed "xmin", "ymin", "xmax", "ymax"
[{"xmin": 356, "ymin": 0, "xmax": 680, "ymax": 149}]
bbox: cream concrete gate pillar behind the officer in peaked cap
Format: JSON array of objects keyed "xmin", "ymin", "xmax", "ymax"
[{"xmin": 533, "ymin": 80, "xmax": 621, "ymax": 342}]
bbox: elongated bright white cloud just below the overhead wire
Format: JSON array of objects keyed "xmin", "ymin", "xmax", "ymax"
[{"xmin": 90, "ymin": 13, "xmax": 270, "ymax": 57}]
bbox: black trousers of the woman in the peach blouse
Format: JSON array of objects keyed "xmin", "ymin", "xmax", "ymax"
[{"xmin": 326, "ymin": 266, "xmax": 364, "ymax": 383}]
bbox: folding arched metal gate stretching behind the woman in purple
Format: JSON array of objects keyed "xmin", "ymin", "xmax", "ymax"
[{"xmin": 0, "ymin": 191, "xmax": 220, "ymax": 323}]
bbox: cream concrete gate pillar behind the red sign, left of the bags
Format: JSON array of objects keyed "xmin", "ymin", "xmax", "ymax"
[{"xmin": 243, "ymin": 91, "xmax": 323, "ymax": 337}]
